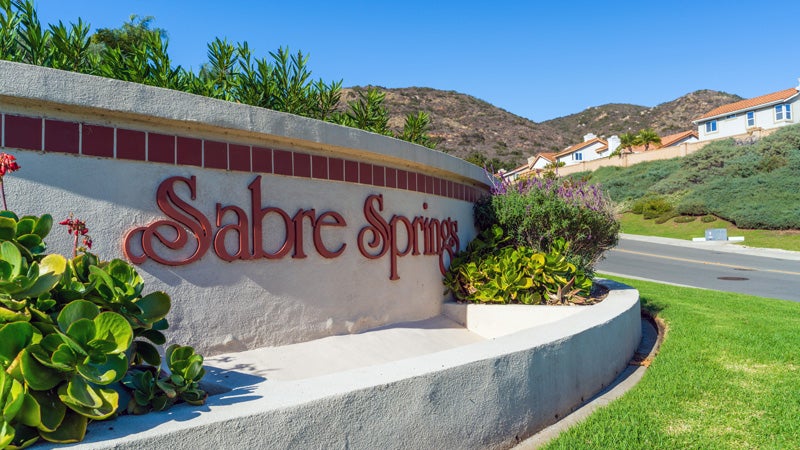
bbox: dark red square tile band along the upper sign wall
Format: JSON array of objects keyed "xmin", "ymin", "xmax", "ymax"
[{"xmin": 0, "ymin": 114, "xmax": 486, "ymax": 202}]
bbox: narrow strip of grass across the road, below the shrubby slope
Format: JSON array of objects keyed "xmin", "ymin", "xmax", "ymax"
[{"xmin": 620, "ymin": 213, "xmax": 800, "ymax": 251}]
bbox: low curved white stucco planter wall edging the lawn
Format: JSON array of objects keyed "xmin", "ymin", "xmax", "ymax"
[{"xmin": 39, "ymin": 282, "xmax": 641, "ymax": 449}]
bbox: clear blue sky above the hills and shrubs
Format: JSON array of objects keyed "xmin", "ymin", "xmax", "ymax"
[{"xmin": 36, "ymin": 0, "xmax": 800, "ymax": 122}]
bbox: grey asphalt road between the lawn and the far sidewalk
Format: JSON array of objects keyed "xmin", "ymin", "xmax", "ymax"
[{"xmin": 595, "ymin": 236, "xmax": 800, "ymax": 302}]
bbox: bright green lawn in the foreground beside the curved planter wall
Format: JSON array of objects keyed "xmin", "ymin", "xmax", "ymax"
[{"xmin": 546, "ymin": 277, "xmax": 800, "ymax": 449}]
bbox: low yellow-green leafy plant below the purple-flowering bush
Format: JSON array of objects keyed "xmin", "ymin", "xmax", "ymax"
[{"xmin": 444, "ymin": 226, "xmax": 592, "ymax": 305}]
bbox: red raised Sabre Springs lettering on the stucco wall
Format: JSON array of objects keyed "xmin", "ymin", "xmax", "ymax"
[{"xmin": 123, "ymin": 175, "xmax": 460, "ymax": 280}]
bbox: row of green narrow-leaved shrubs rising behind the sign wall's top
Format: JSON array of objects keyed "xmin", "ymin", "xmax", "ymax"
[{"xmin": 0, "ymin": 0, "xmax": 436, "ymax": 148}]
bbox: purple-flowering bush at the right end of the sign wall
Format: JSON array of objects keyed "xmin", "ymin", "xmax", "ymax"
[{"xmin": 475, "ymin": 171, "xmax": 619, "ymax": 272}]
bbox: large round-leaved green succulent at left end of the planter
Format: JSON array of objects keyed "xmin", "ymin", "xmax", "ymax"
[{"xmin": 0, "ymin": 211, "xmax": 206, "ymax": 448}]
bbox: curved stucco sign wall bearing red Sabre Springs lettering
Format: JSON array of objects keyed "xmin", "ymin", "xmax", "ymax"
[{"xmin": 0, "ymin": 62, "xmax": 487, "ymax": 354}]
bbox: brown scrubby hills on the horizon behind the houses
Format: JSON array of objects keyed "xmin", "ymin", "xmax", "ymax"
[{"xmin": 342, "ymin": 87, "xmax": 741, "ymax": 167}]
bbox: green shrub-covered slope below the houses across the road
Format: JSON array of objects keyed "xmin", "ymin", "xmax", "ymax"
[{"xmin": 571, "ymin": 125, "xmax": 800, "ymax": 230}]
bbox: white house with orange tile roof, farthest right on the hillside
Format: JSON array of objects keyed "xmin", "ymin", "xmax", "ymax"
[{"xmin": 692, "ymin": 79, "xmax": 800, "ymax": 141}]
